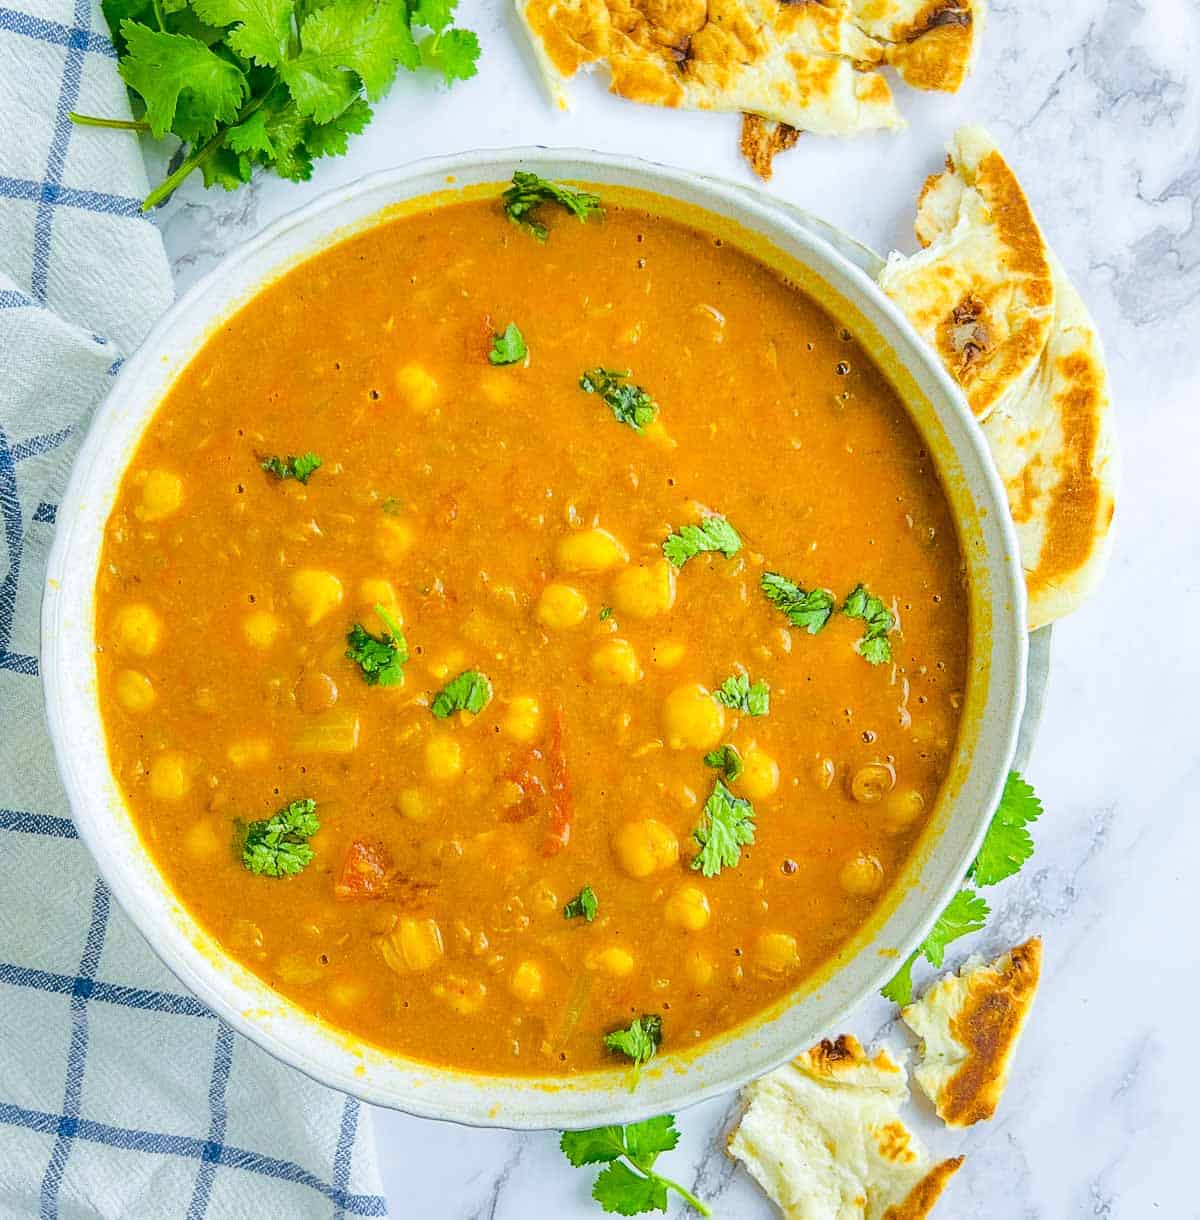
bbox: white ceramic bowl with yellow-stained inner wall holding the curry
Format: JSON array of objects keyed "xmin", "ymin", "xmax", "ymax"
[{"xmin": 41, "ymin": 149, "xmax": 1027, "ymax": 1127}]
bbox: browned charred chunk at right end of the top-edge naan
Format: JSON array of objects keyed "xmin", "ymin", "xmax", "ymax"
[{"xmin": 850, "ymin": 0, "xmax": 987, "ymax": 93}]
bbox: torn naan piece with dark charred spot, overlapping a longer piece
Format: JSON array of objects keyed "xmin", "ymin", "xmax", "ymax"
[{"xmin": 879, "ymin": 127, "xmax": 1054, "ymax": 420}]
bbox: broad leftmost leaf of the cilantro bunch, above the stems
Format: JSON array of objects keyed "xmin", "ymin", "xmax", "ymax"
[{"xmin": 117, "ymin": 17, "xmax": 250, "ymax": 140}]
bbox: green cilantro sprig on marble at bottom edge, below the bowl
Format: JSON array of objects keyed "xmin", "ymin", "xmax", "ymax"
[{"xmin": 559, "ymin": 1114, "xmax": 712, "ymax": 1216}]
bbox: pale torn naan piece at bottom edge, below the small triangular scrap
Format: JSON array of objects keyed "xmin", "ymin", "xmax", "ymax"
[{"xmin": 729, "ymin": 1035, "xmax": 962, "ymax": 1220}]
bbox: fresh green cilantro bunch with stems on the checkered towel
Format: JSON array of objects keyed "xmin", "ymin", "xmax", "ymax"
[{"xmin": 71, "ymin": 0, "xmax": 479, "ymax": 211}]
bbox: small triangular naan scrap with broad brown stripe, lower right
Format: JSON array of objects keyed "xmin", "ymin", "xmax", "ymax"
[{"xmin": 900, "ymin": 937, "xmax": 1041, "ymax": 1127}]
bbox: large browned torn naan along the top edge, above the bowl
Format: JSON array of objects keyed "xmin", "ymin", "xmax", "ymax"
[{"xmin": 516, "ymin": 0, "xmax": 984, "ymax": 173}]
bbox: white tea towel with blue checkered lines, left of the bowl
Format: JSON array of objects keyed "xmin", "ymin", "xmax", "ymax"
[{"xmin": 0, "ymin": 0, "xmax": 387, "ymax": 1220}]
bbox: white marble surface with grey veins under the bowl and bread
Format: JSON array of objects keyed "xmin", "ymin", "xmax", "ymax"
[{"xmin": 160, "ymin": 0, "xmax": 1200, "ymax": 1220}]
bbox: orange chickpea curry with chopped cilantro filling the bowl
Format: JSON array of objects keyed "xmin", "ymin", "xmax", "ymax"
[{"xmin": 96, "ymin": 174, "xmax": 970, "ymax": 1075}]
